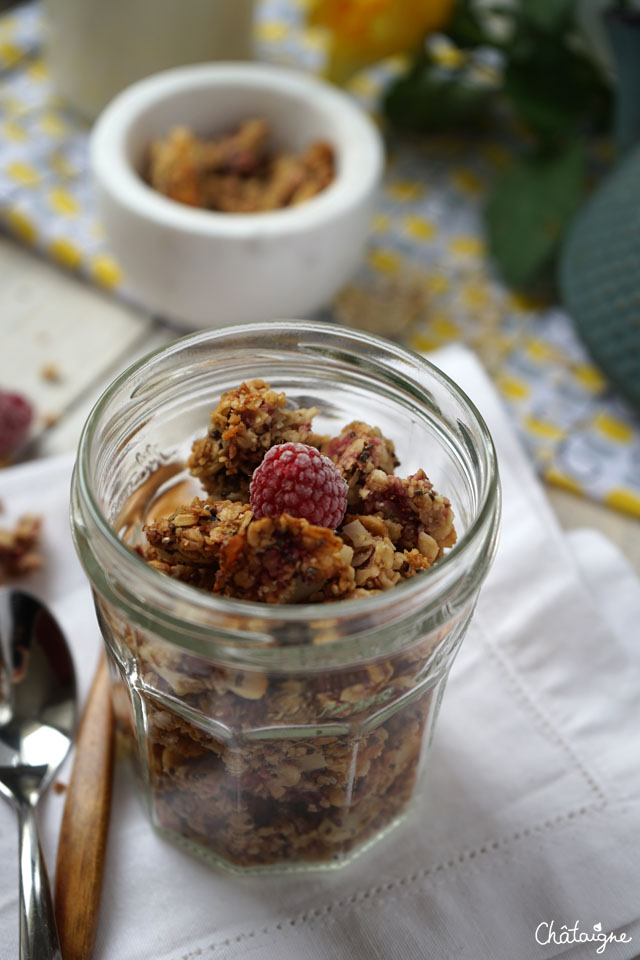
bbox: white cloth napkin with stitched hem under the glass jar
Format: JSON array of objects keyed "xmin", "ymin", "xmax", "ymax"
[{"xmin": 0, "ymin": 348, "xmax": 640, "ymax": 960}]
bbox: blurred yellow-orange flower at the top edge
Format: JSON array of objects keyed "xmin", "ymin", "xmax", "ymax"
[{"xmin": 309, "ymin": 0, "xmax": 454, "ymax": 83}]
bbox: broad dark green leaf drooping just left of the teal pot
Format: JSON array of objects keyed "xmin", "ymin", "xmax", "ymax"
[{"xmin": 486, "ymin": 140, "xmax": 585, "ymax": 287}]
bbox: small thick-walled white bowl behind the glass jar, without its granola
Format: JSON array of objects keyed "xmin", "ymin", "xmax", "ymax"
[{"xmin": 90, "ymin": 63, "xmax": 384, "ymax": 328}]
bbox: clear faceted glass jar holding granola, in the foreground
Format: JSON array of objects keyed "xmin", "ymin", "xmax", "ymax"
[{"xmin": 72, "ymin": 321, "xmax": 500, "ymax": 871}]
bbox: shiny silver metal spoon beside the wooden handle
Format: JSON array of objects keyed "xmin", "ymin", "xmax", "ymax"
[{"xmin": 0, "ymin": 588, "xmax": 76, "ymax": 960}]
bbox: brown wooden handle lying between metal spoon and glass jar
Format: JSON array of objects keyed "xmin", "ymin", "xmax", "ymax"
[{"xmin": 55, "ymin": 653, "xmax": 113, "ymax": 960}]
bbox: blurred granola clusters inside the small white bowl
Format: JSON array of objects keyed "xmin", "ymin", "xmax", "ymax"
[{"xmin": 147, "ymin": 118, "xmax": 335, "ymax": 213}]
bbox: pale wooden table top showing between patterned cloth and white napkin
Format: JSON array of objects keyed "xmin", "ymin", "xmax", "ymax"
[{"xmin": 0, "ymin": 236, "xmax": 640, "ymax": 574}]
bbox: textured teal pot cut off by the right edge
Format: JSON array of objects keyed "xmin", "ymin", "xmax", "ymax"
[{"xmin": 560, "ymin": 11, "xmax": 640, "ymax": 410}]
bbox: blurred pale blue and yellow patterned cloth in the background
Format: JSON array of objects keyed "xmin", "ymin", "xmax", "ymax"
[{"xmin": 0, "ymin": 0, "xmax": 640, "ymax": 515}]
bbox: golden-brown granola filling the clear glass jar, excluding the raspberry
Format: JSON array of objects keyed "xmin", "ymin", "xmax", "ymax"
[{"xmin": 112, "ymin": 380, "xmax": 461, "ymax": 868}]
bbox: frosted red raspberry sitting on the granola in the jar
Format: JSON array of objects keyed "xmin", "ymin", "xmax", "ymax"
[{"xmin": 249, "ymin": 443, "xmax": 347, "ymax": 530}]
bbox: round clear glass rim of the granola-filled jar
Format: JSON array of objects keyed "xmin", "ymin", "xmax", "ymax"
[{"xmin": 72, "ymin": 320, "xmax": 500, "ymax": 633}]
